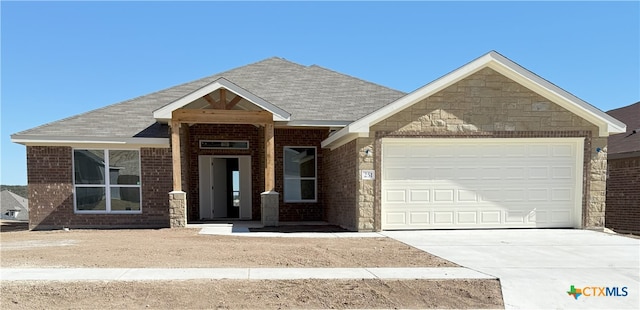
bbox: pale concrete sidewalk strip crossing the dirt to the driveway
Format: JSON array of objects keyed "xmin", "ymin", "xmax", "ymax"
[{"xmin": 0, "ymin": 267, "xmax": 495, "ymax": 281}]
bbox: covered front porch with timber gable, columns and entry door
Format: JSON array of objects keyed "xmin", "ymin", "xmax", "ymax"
[{"xmin": 162, "ymin": 88, "xmax": 328, "ymax": 227}]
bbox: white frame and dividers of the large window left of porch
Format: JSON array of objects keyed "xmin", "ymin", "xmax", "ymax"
[{"xmin": 71, "ymin": 148, "xmax": 142, "ymax": 214}]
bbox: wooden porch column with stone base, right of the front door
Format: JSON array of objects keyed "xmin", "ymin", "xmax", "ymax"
[{"xmin": 260, "ymin": 122, "xmax": 280, "ymax": 226}]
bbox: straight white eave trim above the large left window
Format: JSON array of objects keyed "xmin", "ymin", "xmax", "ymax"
[{"xmin": 11, "ymin": 135, "xmax": 170, "ymax": 148}]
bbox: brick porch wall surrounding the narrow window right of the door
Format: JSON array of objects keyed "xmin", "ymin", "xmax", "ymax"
[{"xmin": 274, "ymin": 128, "xmax": 329, "ymax": 222}]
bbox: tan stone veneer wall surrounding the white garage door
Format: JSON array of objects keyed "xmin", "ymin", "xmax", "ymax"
[{"xmin": 357, "ymin": 68, "xmax": 607, "ymax": 230}]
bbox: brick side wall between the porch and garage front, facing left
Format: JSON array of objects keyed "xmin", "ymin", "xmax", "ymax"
[{"xmin": 323, "ymin": 141, "xmax": 358, "ymax": 230}]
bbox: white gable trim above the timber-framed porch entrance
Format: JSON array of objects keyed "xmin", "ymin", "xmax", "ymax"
[{"xmin": 153, "ymin": 78, "xmax": 291, "ymax": 122}]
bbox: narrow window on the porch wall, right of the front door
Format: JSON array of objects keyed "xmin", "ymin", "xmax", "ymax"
[{"xmin": 284, "ymin": 147, "xmax": 317, "ymax": 202}]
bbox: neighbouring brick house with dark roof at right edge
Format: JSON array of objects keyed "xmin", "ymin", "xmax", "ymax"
[{"xmin": 605, "ymin": 102, "xmax": 640, "ymax": 234}]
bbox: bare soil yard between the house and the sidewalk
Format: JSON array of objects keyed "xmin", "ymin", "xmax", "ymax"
[{"xmin": 0, "ymin": 228, "xmax": 456, "ymax": 268}]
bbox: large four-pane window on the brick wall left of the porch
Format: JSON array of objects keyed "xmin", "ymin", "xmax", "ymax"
[{"xmin": 73, "ymin": 149, "xmax": 142, "ymax": 213}]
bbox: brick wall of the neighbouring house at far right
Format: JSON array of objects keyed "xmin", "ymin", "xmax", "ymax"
[{"xmin": 605, "ymin": 157, "xmax": 640, "ymax": 234}]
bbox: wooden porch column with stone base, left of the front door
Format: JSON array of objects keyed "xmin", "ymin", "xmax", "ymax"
[{"xmin": 169, "ymin": 121, "xmax": 187, "ymax": 228}]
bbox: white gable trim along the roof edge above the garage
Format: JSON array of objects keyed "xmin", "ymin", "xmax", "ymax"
[{"xmin": 322, "ymin": 51, "xmax": 626, "ymax": 147}]
